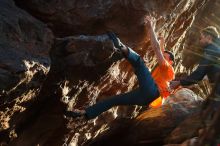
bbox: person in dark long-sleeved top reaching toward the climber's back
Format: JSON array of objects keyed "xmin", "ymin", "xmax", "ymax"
[{"xmin": 170, "ymin": 26, "xmax": 220, "ymax": 106}]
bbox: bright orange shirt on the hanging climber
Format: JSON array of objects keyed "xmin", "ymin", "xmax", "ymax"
[{"xmin": 151, "ymin": 61, "xmax": 175, "ymax": 98}]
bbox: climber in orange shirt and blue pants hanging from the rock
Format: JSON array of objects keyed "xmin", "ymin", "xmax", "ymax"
[{"xmin": 64, "ymin": 16, "xmax": 174, "ymax": 119}]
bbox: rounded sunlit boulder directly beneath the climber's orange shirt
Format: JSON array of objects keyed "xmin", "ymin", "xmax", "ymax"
[{"xmin": 86, "ymin": 89, "xmax": 203, "ymax": 146}]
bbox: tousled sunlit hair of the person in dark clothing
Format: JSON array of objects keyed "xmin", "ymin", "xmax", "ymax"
[{"xmin": 200, "ymin": 26, "xmax": 219, "ymax": 40}]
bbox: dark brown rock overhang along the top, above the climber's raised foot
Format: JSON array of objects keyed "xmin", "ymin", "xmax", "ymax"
[{"xmin": 13, "ymin": 0, "xmax": 179, "ymax": 41}]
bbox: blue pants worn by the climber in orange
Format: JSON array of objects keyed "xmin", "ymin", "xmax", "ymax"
[{"xmin": 85, "ymin": 48, "xmax": 159, "ymax": 119}]
